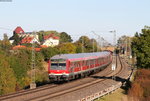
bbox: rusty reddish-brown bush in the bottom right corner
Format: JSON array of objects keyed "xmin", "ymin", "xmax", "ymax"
[{"xmin": 128, "ymin": 69, "xmax": 150, "ymax": 101}]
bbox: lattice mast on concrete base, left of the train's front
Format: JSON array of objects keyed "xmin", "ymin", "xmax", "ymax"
[{"xmin": 30, "ymin": 32, "xmax": 36, "ymax": 89}]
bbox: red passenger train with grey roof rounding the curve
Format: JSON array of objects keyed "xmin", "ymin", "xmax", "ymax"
[{"xmin": 48, "ymin": 51, "xmax": 112, "ymax": 81}]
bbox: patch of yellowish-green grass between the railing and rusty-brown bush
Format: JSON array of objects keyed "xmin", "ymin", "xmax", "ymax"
[{"xmin": 95, "ymin": 88, "xmax": 127, "ymax": 101}]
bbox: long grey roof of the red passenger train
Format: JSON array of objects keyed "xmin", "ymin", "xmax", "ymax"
[{"xmin": 51, "ymin": 51, "xmax": 110, "ymax": 60}]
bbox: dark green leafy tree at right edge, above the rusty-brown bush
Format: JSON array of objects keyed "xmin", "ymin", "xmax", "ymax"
[{"xmin": 132, "ymin": 28, "xmax": 150, "ymax": 68}]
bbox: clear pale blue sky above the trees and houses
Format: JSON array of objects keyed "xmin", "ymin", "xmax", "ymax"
[{"xmin": 0, "ymin": 0, "xmax": 150, "ymax": 42}]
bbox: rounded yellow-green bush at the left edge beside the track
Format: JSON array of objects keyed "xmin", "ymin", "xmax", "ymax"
[{"xmin": 0, "ymin": 50, "xmax": 16, "ymax": 95}]
